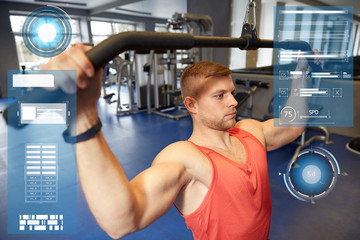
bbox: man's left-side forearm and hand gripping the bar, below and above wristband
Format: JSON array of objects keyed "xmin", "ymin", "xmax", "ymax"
[{"xmin": 41, "ymin": 44, "xmax": 140, "ymax": 237}]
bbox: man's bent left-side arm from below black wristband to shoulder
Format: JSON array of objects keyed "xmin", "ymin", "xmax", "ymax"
[{"xmin": 77, "ymin": 133, "xmax": 190, "ymax": 238}]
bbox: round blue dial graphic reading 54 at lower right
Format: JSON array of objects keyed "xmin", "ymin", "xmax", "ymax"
[{"xmin": 284, "ymin": 147, "xmax": 340, "ymax": 202}]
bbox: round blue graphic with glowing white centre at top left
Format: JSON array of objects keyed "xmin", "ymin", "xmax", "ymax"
[{"xmin": 22, "ymin": 6, "xmax": 71, "ymax": 57}]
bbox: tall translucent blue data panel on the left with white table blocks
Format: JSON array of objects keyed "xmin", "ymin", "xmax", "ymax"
[{"xmin": 7, "ymin": 70, "xmax": 77, "ymax": 234}]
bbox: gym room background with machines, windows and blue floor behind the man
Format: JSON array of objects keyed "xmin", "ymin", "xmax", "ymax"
[{"xmin": 0, "ymin": 0, "xmax": 360, "ymax": 239}]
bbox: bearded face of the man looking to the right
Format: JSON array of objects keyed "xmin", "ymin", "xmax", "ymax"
[{"xmin": 197, "ymin": 76, "xmax": 237, "ymax": 131}]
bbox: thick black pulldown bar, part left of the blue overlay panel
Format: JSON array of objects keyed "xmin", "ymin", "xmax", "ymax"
[{"xmin": 86, "ymin": 32, "xmax": 273, "ymax": 68}]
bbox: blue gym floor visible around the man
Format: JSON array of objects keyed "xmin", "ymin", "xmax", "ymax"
[{"xmin": 0, "ymin": 94, "xmax": 360, "ymax": 240}]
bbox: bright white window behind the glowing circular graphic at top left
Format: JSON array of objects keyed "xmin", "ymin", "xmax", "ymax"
[{"xmin": 10, "ymin": 14, "xmax": 82, "ymax": 70}]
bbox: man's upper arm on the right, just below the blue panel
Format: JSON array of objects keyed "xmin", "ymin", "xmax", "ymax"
[{"xmin": 261, "ymin": 119, "xmax": 304, "ymax": 151}]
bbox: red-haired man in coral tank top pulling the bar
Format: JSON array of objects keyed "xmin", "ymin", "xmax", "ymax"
[{"xmin": 42, "ymin": 44, "xmax": 307, "ymax": 240}]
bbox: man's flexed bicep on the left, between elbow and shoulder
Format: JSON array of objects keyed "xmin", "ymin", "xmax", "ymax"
[{"xmin": 130, "ymin": 162, "xmax": 191, "ymax": 229}]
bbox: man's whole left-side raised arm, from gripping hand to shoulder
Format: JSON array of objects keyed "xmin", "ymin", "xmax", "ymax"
[{"xmin": 42, "ymin": 45, "xmax": 190, "ymax": 238}]
